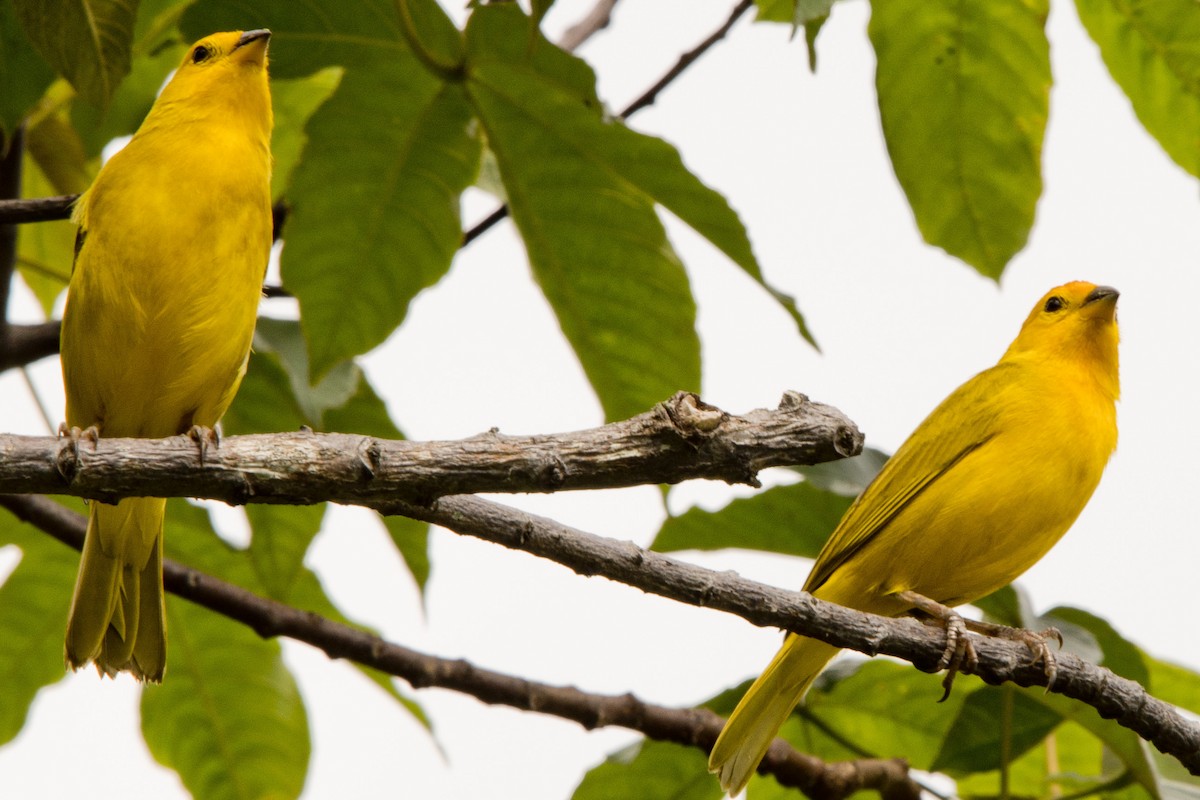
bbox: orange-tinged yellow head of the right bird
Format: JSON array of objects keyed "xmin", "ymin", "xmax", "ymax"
[{"xmin": 1004, "ymin": 281, "xmax": 1120, "ymax": 396}]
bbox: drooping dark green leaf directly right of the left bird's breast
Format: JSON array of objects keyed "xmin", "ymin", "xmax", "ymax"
[{"xmin": 282, "ymin": 73, "xmax": 480, "ymax": 375}]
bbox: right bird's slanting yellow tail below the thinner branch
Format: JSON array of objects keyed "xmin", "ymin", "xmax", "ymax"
[{"xmin": 708, "ymin": 633, "xmax": 838, "ymax": 795}]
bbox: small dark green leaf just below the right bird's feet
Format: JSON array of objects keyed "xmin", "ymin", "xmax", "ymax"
[{"xmin": 930, "ymin": 684, "xmax": 1062, "ymax": 776}]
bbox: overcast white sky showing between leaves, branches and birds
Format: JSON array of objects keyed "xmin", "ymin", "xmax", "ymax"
[{"xmin": 0, "ymin": 0, "xmax": 1200, "ymax": 800}]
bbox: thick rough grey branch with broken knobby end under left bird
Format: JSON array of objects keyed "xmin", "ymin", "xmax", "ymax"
[{"xmin": 0, "ymin": 392, "xmax": 863, "ymax": 506}]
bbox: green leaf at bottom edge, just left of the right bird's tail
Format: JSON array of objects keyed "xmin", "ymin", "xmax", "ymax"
[{"xmin": 571, "ymin": 740, "xmax": 725, "ymax": 800}]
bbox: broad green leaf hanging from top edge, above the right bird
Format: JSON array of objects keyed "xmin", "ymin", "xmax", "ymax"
[{"xmin": 868, "ymin": 0, "xmax": 1051, "ymax": 279}]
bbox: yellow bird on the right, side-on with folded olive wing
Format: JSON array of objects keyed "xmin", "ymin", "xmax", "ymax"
[{"xmin": 708, "ymin": 282, "xmax": 1120, "ymax": 794}]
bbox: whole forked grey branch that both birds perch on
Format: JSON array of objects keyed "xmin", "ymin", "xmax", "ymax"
[{"xmin": 0, "ymin": 392, "xmax": 1200, "ymax": 774}]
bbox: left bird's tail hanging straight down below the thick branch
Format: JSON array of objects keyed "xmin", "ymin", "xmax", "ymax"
[{"xmin": 66, "ymin": 498, "xmax": 167, "ymax": 682}]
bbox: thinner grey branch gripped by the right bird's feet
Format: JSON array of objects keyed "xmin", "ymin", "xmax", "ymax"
[{"xmin": 378, "ymin": 497, "xmax": 1200, "ymax": 775}]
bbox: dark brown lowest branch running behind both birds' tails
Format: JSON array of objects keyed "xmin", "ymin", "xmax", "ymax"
[{"xmin": 0, "ymin": 495, "xmax": 920, "ymax": 800}]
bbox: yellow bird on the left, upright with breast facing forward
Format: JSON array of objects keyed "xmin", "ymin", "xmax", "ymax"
[{"xmin": 61, "ymin": 30, "xmax": 272, "ymax": 682}]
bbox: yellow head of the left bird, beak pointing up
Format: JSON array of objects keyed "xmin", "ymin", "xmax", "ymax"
[{"xmin": 146, "ymin": 29, "xmax": 272, "ymax": 136}]
